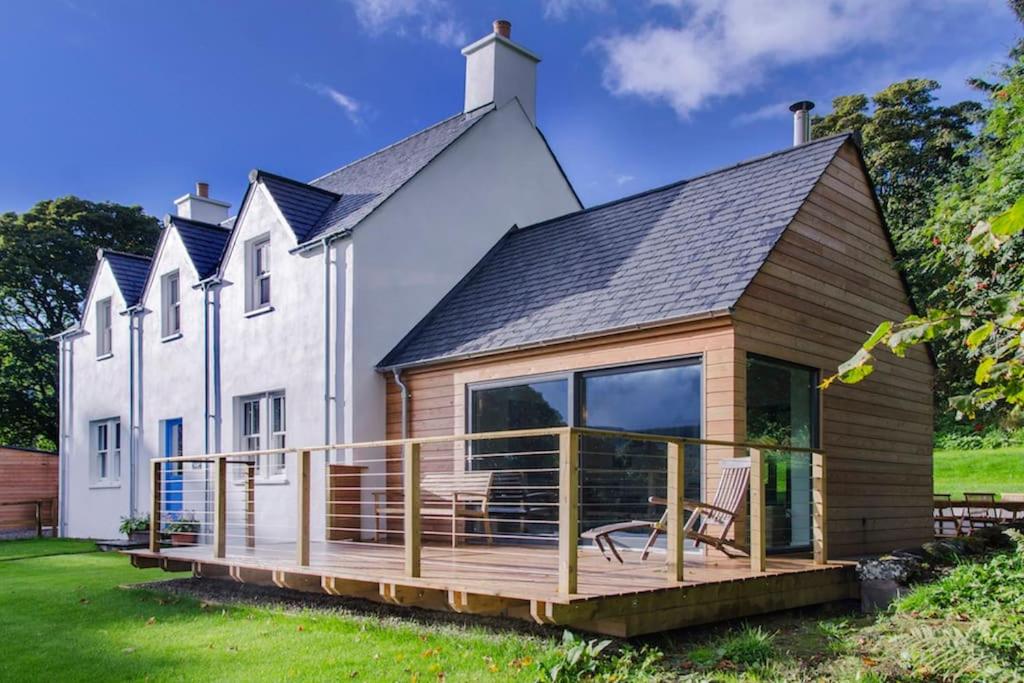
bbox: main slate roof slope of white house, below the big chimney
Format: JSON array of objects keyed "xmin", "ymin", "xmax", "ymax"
[{"xmin": 299, "ymin": 104, "xmax": 494, "ymax": 244}]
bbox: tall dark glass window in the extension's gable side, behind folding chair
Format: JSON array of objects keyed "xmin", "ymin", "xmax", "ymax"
[{"xmin": 746, "ymin": 355, "xmax": 818, "ymax": 550}]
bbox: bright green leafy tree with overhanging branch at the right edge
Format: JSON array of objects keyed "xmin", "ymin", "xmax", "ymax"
[{"xmin": 823, "ymin": 46, "xmax": 1024, "ymax": 420}]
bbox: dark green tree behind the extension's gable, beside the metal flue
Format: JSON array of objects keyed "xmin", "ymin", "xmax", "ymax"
[{"xmin": 813, "ymin": 79, "xmax": 982, "ymax": 303}]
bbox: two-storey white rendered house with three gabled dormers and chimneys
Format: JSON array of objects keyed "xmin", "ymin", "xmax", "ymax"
[{"xmin": 58, "ymin": 23, "xmax": 581, "ymax": 537}]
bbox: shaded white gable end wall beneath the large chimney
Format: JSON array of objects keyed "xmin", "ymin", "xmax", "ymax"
[{"xmin": 344, "ymin": 101, "xmax": 580, "ymax": 485}]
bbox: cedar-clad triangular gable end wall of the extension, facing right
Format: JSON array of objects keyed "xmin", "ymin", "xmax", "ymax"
[{"xmin": 734, "ymin": 143, "xmax": 933, "ymax": 557}]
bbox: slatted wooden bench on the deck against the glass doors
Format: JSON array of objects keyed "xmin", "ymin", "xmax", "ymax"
[{"xmin": 374, "ymin": 472, "xmax": 494, "ymax": 548}]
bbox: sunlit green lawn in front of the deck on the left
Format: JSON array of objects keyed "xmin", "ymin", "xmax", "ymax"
[{"xmin": 0, "ymin": 540, "xmax": 554, "ymax": 681}]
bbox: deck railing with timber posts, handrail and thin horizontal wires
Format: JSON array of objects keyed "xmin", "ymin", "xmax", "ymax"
[{"xmin": 150, "ymin": 427, "xmax": 828, "ymax": 595}]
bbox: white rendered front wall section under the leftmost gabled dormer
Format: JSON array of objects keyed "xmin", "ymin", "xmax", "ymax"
[{"xmin": 67, "ymin": 260, "xmax": 129, "ymax": 539}]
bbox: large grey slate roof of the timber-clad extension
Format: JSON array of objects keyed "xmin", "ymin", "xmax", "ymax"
[{"xmin": 379, "ymin": 134, "xmax": 850, "ymax": 368}]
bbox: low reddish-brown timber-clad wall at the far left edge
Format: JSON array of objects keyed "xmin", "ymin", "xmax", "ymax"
[{"xmin": 0, "ymin": 446, "xmax": 57, "ymax": 529}]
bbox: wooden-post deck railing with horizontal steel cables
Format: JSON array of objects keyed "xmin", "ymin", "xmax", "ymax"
[{"xmin": 150, "ymin": 427, "xmax": 827, "ymax": 594}]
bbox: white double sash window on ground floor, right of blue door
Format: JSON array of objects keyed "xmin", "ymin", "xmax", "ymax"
[{"xmin": 234, "ymin": 391, "xmax": 288, "ymax": 483}]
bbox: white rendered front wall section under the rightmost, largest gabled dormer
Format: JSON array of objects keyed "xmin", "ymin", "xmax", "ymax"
[{"xmin": 219, "ymin": 185, "xmax": 338, "ymax": 542}]
